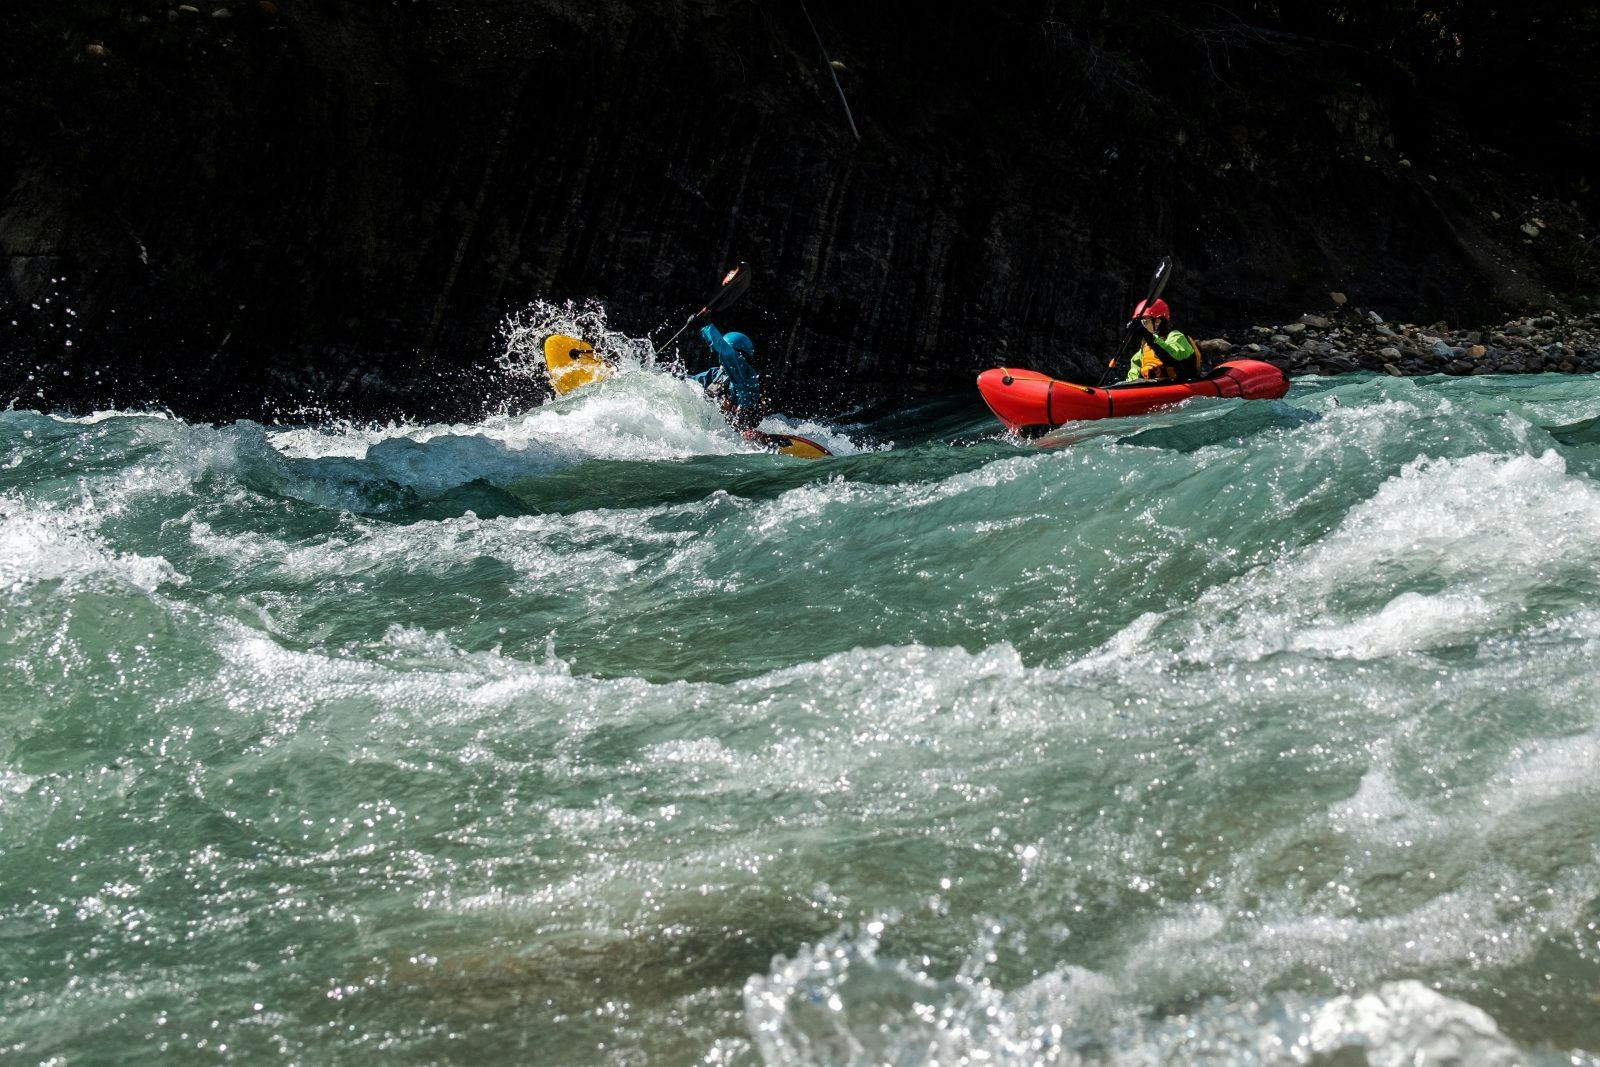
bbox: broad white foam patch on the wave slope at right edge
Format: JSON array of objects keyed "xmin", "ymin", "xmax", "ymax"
[{"xmin": 1086, "ymin": 451, "xmax": 1600, "ymax": 664}]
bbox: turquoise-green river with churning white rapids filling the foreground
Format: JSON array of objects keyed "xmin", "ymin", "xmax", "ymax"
[{"xmin": 0, "ymin": 348, "xmax": 1600, "ymax": 1064}]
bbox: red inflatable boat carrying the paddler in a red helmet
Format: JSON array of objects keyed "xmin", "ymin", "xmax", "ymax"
[{"xmin": 978, "ymin": 360, "xmax": 1290, "ymax": 435}]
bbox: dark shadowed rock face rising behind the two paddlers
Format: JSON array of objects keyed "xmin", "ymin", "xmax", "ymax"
[{"xmin": 0, "ymin": 0, "xmax": 1594, "ymax": 418}]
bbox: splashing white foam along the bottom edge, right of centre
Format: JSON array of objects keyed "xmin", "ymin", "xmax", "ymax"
[{"xmin": 744, "ymin": 918, "xmax": 1574, "ymax": 1067}]
